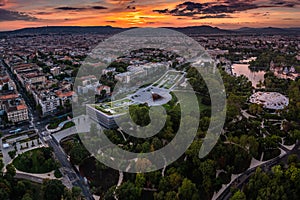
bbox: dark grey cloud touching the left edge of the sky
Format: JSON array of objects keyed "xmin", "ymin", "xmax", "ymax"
[{"xmin": 0, "ymin": 8, "xmax": 38, "ymax": 21}]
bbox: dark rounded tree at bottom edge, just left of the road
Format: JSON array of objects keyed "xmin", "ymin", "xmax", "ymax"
[{"xmin": 43, "ymin": 180, "xmax": 65, "ymax": 200}]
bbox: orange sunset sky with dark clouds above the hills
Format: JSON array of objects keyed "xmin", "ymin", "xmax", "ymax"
[{"xmin": 0, "ymin": 0, "xmax": 300, "ymax": 31}]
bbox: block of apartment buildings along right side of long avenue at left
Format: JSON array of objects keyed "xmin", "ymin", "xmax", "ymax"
[{"xmin": 6, "ymin": 57, "xmax": 74, "ymax": 116}]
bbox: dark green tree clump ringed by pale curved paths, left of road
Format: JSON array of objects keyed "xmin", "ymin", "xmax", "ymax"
[{"xmin": 13, "ymin": 148, "xmax": 58, "ymax": 174}]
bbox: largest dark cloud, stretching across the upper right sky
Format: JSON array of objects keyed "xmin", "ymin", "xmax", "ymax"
[{"xmin": 153, "ymin": 0, "xmax": 300, "ymax": 18}]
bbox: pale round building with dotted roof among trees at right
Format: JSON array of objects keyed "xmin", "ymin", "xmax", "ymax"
[{"xmin": 249, "ymin": 92, "xmax": 289, "ymax": 110}]
